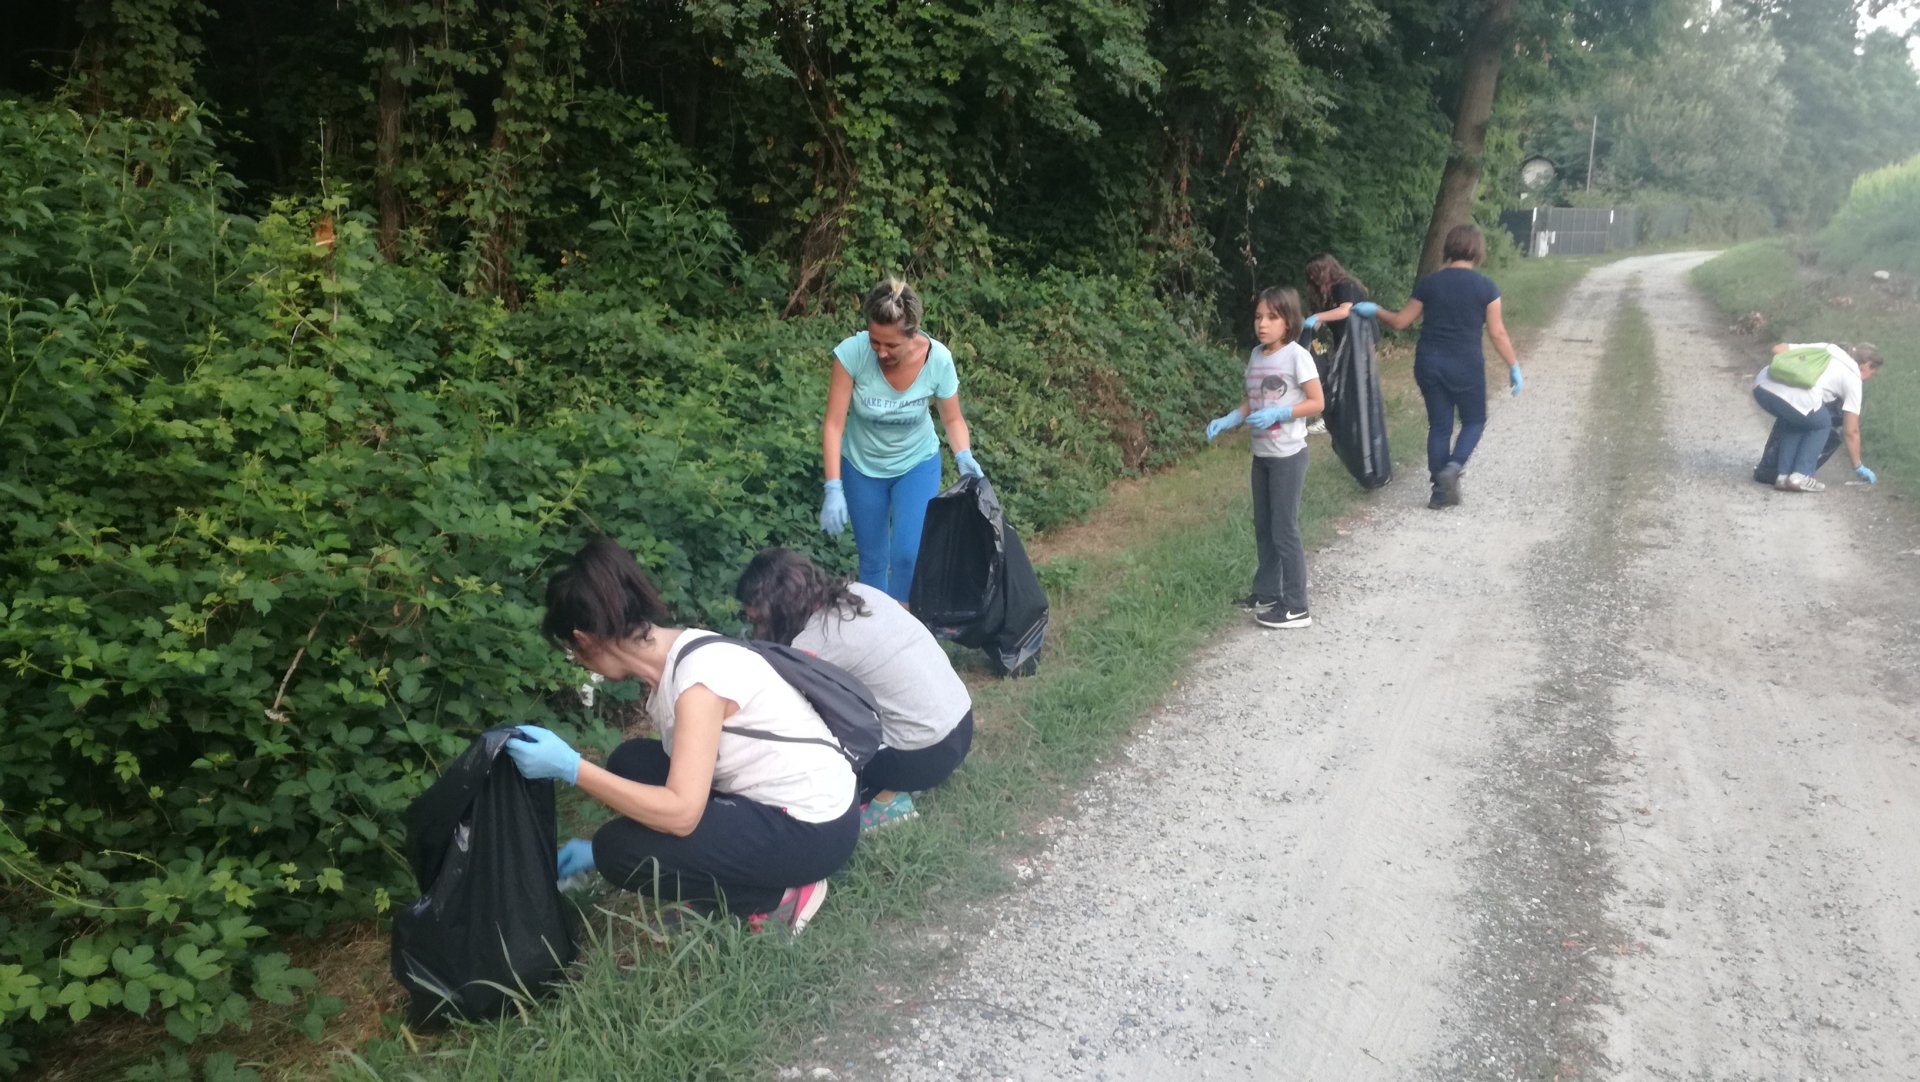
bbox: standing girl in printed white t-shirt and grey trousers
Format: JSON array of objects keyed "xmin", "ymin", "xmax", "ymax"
[{"xmin": 1206, "ymin": 288, "xmax": 1327, "ymax": 627}]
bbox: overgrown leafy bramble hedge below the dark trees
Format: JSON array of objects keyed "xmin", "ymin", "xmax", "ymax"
[{"xmin": 0, "ymin": 102, "xmax": 1236, "ymax": 1070}]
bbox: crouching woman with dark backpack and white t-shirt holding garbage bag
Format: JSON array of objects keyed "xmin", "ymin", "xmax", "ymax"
[{"xmin": 507, "ymin": 537, "xmax": 860, "ymax": 932}]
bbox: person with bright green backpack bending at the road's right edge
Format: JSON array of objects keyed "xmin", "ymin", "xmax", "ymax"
[{"xmin": 1753, "ymin": 341, "xmax": 1882, "ymax": 493}]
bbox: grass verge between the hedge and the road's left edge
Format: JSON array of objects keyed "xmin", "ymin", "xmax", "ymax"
[{"xmin": 336, "ymin": 259, "xmax": 1597, "ymax": 1082}]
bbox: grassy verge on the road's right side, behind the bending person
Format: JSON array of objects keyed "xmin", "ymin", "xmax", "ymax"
[{"xmin": 1693, "ymin": 238, "xmax": 1920, "ymax": 495}]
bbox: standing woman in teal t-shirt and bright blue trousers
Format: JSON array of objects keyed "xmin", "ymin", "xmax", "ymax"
[{"xmin": 820, "ymin": 278, "xmax": 987, "ymax": 602}]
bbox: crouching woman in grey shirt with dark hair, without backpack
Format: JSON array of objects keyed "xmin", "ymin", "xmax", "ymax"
[{"xmin": 733, "ymin": 549, "xmax": 973, "ymax": 831}]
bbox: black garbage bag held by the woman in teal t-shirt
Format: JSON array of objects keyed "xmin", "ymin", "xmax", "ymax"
[{"xmin": 908, "ymin": 478, "xmax": 1046, "ymax": 675}]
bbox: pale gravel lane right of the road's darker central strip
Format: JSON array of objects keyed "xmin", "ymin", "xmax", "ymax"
[{"xmin": 1605, "ymin": 255, "xmax": 1920, "ymax": 1080}]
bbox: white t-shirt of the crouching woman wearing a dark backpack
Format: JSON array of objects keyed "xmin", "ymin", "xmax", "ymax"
[{"xmin": 647, "ymin": 627, "xmax": 854, "ymax": 823}]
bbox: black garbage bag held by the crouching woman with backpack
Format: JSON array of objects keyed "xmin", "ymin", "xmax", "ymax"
[{"xmin": 392, "ymin": 727, "xmax": 574, "ymax": 1028}]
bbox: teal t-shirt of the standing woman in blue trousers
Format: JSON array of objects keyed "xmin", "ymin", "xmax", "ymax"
[{"xmin": 833, "ymin": 330, "xmax": 960, "ymax": 478}]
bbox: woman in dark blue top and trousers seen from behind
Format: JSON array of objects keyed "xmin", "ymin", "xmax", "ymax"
[{"xmin": 1354, "ymin": 224, "xmax": 1526, "ymax": 508}]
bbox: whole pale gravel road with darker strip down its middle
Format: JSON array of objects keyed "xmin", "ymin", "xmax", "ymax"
[{"xmin": 864, "ymin": 253, "xmax": 1920, "ymax": 1082}]
